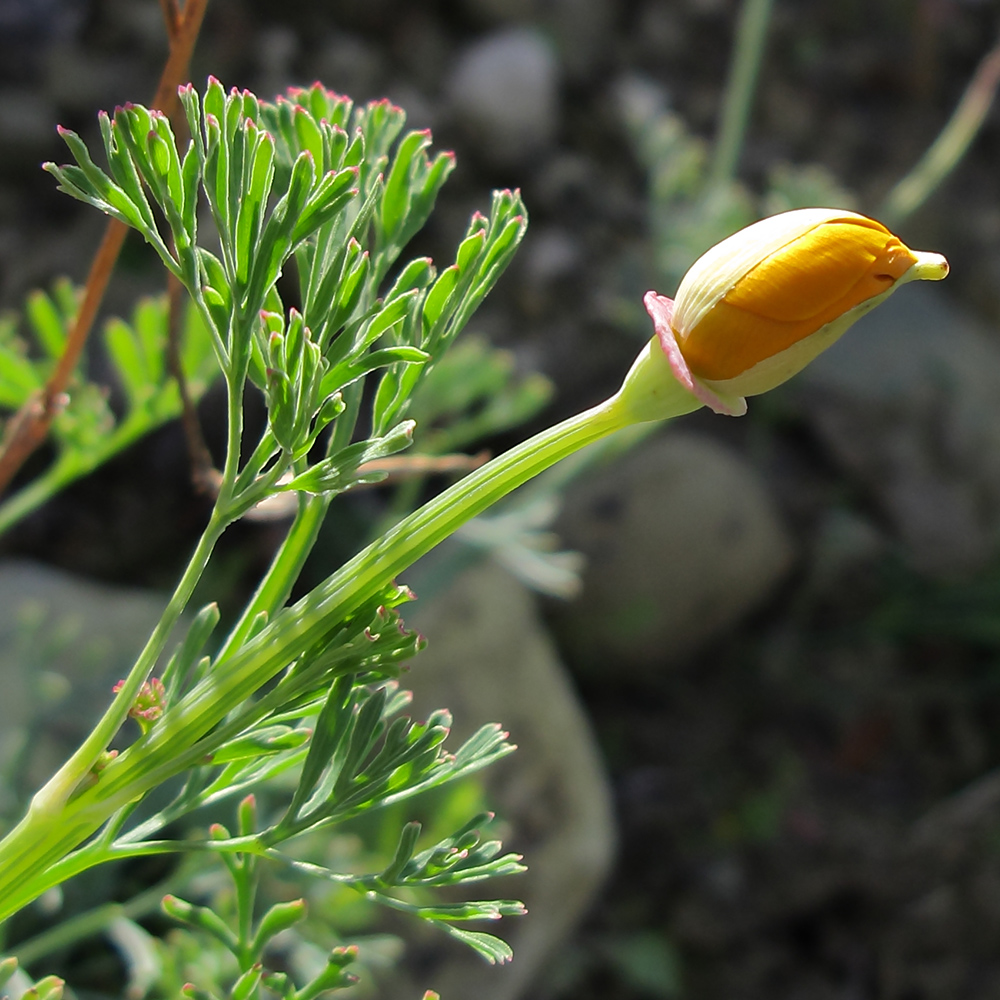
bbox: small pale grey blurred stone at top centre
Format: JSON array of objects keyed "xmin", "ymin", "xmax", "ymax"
[{"xmin": 446, "ymin": 28, "xmax": 558, "ymax": 166}]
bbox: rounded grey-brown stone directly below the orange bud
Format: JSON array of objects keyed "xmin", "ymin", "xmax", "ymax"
[{"xmin": 553, "ymin": 430, "xmax": 793, "ymax": 672}]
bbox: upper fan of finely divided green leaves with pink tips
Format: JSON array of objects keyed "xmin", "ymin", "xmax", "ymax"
[{"xmin": 46, "ymin": 80, "xmax": 526, "ymax": 513}]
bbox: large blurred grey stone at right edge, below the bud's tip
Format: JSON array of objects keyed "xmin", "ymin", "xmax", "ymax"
[{"xmin": 787, "ymin": 284, "xmax": 1000, "ymax": 576}]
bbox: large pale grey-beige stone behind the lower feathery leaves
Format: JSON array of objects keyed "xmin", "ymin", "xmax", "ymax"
[{"xmin": 392, "ymin": 563, "xmax": 615, "ymax": 1000}]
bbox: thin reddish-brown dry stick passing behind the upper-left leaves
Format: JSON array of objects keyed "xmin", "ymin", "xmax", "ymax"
[{"xmin": 0, "ymin": 0, "xmax": 208, "ymax": 492}]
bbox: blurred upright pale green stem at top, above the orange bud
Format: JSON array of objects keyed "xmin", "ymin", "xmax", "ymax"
[{"xmin": 711, "ymin": 0, "xmax": 773, "ymax": 186}]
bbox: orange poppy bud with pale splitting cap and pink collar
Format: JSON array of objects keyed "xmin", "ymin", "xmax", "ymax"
[{"xmin": 626, "ymin": 208, "xmax": 948, "ymax": 419}]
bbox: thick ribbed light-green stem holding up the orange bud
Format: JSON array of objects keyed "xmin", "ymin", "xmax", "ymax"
[{"xmin": 0, "ymin": 352, "xmax": 700, "ymax": 920}]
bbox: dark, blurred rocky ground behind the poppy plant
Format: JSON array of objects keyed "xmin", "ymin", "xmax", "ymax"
[{"xmin": 0, "ymin": 0, "xmax": 1000, "ymax": 1000}]
